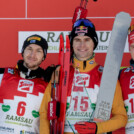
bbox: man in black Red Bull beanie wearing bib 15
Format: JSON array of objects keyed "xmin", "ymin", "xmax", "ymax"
[{"xmin": 40, "ymin": 19, "xmax": 127, "ymax": 134}]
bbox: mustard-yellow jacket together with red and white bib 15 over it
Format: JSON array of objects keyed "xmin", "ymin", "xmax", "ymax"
[{"xmin": 40, "ymin": 58, "xmax": 127, "ymax": 134}]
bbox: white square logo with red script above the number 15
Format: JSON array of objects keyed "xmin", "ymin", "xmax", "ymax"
[{"xmin": 75, "ymin": 74, "xmax": 90, "ymax": 87}]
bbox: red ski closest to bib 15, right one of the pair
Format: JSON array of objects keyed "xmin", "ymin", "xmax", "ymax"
[{"xmin": 58, "ymin": 36, "xmax": 70, "ymax": 134}]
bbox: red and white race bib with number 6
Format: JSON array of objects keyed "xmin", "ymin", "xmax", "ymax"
[{"xmin": 0, "ymin": 68, "xmax": 47, "ymax": 134}]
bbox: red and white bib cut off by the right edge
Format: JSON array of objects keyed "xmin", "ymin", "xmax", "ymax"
[{"xmin": 120, "ymin": 67, "xmax": 134, "ymax": 134}]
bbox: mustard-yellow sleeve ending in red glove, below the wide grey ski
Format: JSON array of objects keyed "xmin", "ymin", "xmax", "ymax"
[{"xmin": 97, "ymin": 81, "xmax": 127, "ymax": 134}]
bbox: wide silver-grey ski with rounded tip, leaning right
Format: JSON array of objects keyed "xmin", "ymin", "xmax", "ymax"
[{"xmin": 94, "ymin": 12, "xmax": 131, "ymax": 122}]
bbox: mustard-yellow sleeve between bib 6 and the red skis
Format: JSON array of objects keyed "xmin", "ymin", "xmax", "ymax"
[{"xmin": 40, "ymin": 82, "xmax": 51, "ymax": 134}]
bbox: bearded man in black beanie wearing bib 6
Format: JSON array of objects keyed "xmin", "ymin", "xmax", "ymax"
[{"xmin": 0, "ymin": 35, "xmax": 49, "ymax": 134}]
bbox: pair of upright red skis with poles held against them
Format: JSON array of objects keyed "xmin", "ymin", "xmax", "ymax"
[{"xmin": 48, "ymin": 35, "xmax": 70, "ymax": 134}]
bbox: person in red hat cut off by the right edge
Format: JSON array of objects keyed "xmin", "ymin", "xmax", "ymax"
[{"xmin": 119, "ymin": 25, "xmax": 134, "ymax": 134}]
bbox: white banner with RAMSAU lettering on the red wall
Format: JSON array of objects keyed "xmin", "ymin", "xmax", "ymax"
[{"xmin": 18, "ymin": 31, "xmax": 129, "ymax": 53}]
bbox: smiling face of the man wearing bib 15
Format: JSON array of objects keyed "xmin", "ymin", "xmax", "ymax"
[{"xmin": 73, "ymin": 35, "xmax": 94, "ymax": 61}]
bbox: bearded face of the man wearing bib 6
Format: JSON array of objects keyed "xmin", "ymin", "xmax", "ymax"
[{"xmin": 23, "ymin": 44, "xmax": 44, "ymax": 70}]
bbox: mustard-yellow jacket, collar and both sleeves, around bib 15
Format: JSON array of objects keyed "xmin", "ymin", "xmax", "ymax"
[{"xmin": 40, "ymin": 58, "xmax": 127, "ymax": 134}]
